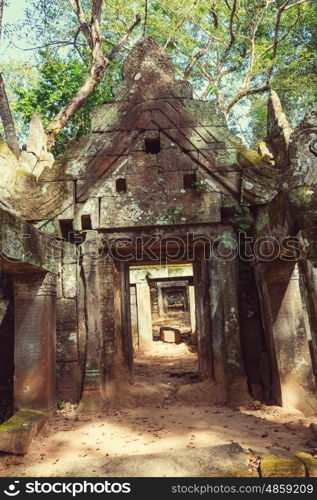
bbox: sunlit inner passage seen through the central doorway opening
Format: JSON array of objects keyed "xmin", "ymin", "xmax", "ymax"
[{"xmin": 130, "ymin": 264, "xmax": 198, "ymax": 391}]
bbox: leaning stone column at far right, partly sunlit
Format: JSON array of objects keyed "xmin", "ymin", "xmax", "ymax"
[{"xmin": 257, "ymin": 261, "xmax": 317, "ymax": 415}]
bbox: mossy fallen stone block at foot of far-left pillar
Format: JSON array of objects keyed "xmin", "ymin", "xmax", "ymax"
[{"xmin": 0, "ymin": 409, "xmax": 48, "ymax": 455}]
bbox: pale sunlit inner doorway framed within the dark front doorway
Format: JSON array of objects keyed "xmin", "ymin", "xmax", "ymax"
[{"xmin": 129, "ymin": 264, "xmax": 197, "ymax": 350}]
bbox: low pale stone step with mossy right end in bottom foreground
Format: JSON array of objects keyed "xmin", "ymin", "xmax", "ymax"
[{"xmin": 65, "ymin": 443, "xmax": 317, "ymax": 477}]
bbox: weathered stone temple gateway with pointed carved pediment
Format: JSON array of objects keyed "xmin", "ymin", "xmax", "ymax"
[{"xmin": 0, "ymin": 38, "xmax": 317, "ymax": 434}]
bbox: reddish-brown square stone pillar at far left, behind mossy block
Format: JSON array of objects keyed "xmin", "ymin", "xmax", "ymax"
[{"xmin": 14, "ymin": 273, "xmax": 56, "ymax": 413}]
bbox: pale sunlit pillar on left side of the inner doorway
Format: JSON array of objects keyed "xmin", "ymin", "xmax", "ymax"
[{"xmin": 136, "ymin": 283, "xmax": 153, "ymax": 350}]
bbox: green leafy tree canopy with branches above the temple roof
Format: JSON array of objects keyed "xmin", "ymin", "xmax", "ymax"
[{"xmin": 2, "ymin": 0, "xmax": 317, "ymax": 152}]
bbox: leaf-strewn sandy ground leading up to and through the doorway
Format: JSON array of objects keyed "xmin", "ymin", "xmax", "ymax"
[{"xmin": 0, "ymin": 343, "xmax": 312, "ymax": 477}]
